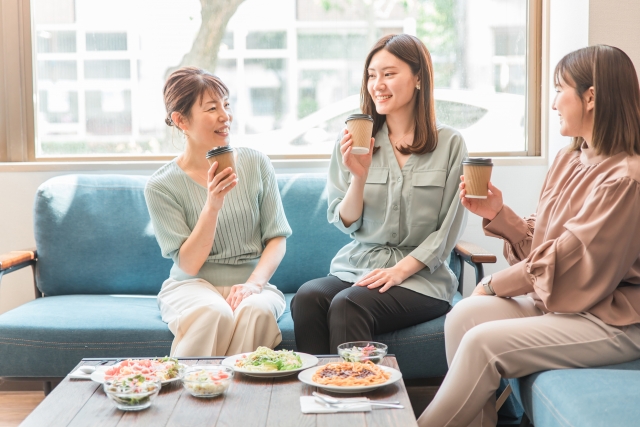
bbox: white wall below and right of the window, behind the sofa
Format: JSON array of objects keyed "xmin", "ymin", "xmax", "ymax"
[{"xmin": 0, "ymin": 0, "xmax": 596, "ymax": 313}]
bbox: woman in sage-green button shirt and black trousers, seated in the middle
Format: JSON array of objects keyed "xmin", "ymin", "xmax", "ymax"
[{"xmin": 291, "ymin": 34, "xmax": 467, "ymax": 354}]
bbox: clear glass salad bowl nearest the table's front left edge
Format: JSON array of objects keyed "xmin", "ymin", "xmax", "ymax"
[{"xmin": 103, "ymin": 375, "xmax": 162, "ymax": 411}]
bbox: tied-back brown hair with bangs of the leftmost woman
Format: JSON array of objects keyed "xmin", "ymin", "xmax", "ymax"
[{"xmin": 164, "ymin": 67, "xmax": 229, "ymax": 126}]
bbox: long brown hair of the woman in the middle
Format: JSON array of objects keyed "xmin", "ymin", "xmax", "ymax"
[{"xmin": 360, "ymin": 34, "xmax": 438, "ymax": 154}]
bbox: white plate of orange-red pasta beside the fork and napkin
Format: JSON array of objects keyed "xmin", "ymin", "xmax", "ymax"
[{"xmin": 298, "ymin": 361, "xmax": 402, "ymax": 393}]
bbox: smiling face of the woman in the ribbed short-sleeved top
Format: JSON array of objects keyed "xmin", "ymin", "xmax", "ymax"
[{"xmin": 180, "ymin": 91, "xmax": 233, "ymax": 150}]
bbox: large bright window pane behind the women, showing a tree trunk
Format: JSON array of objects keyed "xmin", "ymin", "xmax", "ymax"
[{"xmin": 0, "ymin": 0, "xmax": 540, "ymax": 159}]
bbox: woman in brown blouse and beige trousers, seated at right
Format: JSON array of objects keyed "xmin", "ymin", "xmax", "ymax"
[{"xmin": 419, "ymin": 45, "xmax": 640, "ymax": 427}]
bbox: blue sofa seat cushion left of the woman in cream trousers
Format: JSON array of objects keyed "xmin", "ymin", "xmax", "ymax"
[{"xmin": 0, "ymin": 295, "xmax": 173, "ymax": 377}]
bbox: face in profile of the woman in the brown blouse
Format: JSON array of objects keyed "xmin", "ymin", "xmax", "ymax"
[{"xmin": 551, "ymin": 77, "xmax": 594, "ymax": 142}]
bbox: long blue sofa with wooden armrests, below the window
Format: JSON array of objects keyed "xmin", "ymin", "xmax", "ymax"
[{"xmin": 0, "ymin": 174, "xmax": 495, "ymax": 398}]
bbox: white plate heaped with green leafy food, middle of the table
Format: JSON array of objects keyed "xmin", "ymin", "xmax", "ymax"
[{"xmin": 221, "ymin": 347, "xmax": 318, "ymax": 378}]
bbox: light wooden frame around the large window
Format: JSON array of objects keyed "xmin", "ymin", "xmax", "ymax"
[{"xmin": 0, "ymin": 0, "xmax": 549, "ymax": 167}]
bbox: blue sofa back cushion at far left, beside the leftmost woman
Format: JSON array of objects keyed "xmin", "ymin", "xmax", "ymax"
[{"xmin": 34, "ymin": 175, "xmax": 172, "ymax": 295}]
